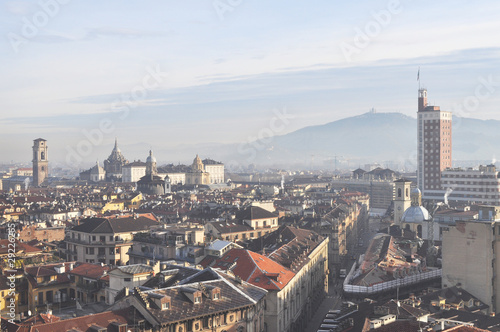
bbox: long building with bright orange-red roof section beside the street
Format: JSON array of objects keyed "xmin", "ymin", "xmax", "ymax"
[{"xmin": 201, "ymin": 227, "xmax": 329, "ymax": 332}]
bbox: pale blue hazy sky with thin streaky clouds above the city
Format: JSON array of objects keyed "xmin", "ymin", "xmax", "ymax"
[{"xmin": 0, "ymin": 0, "xmax": 500, "ymax": 162}]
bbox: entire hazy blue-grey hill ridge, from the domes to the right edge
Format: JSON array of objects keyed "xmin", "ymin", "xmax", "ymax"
[{"xmin": 47, "ymin": 112, "xmax": 500, "ymax": 170}]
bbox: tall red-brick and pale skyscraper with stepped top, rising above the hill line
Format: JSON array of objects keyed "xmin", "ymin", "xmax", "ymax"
[{"xmin": 417, "ymin": 89, "xmax": 452, "ymax": 199}]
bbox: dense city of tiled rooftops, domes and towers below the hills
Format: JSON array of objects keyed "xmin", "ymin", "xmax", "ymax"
[{"xmin": 0, "ymin": 89, "xmax": 500, "ymax": 331}]
